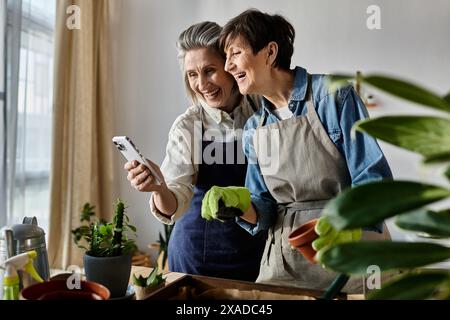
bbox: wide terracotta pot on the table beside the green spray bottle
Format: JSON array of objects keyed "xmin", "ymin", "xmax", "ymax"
[{"xmin": 21, "ymin": 280, "xmax": 110, "ymax": 300}]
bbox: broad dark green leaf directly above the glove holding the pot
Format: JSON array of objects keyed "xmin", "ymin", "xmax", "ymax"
[{"xmin": 324, "ymin": 181, "xmax": 450, "ymax": 230}]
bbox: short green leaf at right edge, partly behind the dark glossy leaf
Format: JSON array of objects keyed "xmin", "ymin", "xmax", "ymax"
[{"xmin": 395, "ymin": 208, "xmax": 450, "ymax": 237}]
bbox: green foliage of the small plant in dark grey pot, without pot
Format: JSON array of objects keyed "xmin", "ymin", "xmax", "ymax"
[{"xmin": 72, "ymin": 199, "xmax": 136, "ymax": 257}]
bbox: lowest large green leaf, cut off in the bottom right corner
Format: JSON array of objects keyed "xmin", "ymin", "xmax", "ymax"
[{"xmin": 368, "ymin": 272, "xmax": 450, "ymax": 300}]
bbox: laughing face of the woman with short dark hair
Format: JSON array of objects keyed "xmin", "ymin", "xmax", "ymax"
[{"xmin": 225, "ymin": 36, "xmax": 272, "ymax": 95}]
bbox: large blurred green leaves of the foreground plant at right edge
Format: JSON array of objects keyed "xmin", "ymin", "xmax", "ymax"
[{"xmin": 320, "ymin": 74, "xmax": 450, "ymax": 299}]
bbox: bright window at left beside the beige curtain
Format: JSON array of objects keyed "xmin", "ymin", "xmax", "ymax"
[{"xmin": 0, "ymin": 0, "xmax": 56, "ymax": 233}]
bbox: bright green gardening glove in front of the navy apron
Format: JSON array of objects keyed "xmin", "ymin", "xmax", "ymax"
[{"xmin": 202, "ymin": 186, "xmax": 251, "ymax": 221}]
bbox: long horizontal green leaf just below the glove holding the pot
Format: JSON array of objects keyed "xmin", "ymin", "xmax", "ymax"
[{"xmin": 320, "ymin": 241, "xmax": 450, "ymax": 274}]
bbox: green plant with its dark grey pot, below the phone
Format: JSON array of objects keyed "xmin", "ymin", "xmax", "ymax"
[{"xmin": 72, "ymin": 199, "xmax": 136, "ymax": 298}]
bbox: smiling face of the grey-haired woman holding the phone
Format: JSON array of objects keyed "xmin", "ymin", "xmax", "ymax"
[{"xmin": 184, "ymin": 48, "xmax": 240, "ymax": 112}]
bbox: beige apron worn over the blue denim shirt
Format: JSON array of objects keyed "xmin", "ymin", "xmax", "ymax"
[{"xmin": 253, "ymin": 76, "xmax": 390, "ymax": 292}]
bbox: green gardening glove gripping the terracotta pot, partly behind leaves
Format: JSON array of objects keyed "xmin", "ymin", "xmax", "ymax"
[{"xmin": 312, "ymin": 216, "xmax": 362, "ymax": 262}]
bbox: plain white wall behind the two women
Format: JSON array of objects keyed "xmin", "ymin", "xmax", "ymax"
[{"xmin": 112, "ymin": 0, "xmax": 450, "ymax": 258}]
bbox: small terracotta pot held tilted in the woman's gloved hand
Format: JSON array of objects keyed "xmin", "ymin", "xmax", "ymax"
[{"xmin": 288, "ymin": 219, "xmax": 319, "ymax": 263}]
